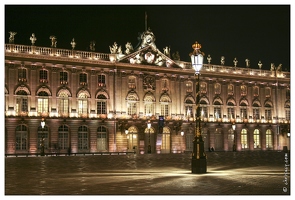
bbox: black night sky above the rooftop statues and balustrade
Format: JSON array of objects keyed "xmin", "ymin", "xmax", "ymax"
[{"xmin": 4, "ymin": 4, "xmax": 290, "ymax": 71}]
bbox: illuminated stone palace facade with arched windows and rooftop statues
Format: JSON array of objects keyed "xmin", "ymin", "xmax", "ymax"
[{"xmin": 5, "ymin": 30, "xmax": 290, "ymax": 154}]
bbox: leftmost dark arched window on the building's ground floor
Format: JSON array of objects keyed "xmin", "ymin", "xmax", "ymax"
[{"xmin": 15, "ymin": 124, "xmax": 28, "ymax": 150}]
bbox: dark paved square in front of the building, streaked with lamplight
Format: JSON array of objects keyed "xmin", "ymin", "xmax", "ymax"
[{"xmin": 5, "ymin": 151, "xmax": 291, "ymax": 195}]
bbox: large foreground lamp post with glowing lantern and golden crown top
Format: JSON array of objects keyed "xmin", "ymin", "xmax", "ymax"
[{"xmin": 190, "ymin": 42, "xmax": 207, "ymax": 174}]
